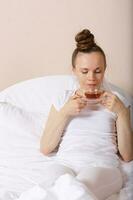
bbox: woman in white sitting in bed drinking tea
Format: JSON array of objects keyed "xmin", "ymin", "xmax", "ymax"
[{"xmin": 40, "ymin": 29, "xmax": 133, "ymax": 200}]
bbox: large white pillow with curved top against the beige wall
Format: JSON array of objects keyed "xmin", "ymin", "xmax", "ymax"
[{"xmin": 0, "ymin": 75, "xmax": 77, "ymax": 113}]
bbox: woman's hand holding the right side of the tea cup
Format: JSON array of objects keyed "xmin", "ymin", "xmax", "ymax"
[{"xmin": 100, "ymin": 92, "xmax": 126, "ymax": 115}]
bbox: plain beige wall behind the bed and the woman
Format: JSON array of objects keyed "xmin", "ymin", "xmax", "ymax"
[{"xmin": 0, "ymin": 0, "xmax": 133, "ymax": 94}]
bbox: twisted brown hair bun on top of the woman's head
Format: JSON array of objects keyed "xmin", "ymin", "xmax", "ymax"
[{"xmin": 75, "ymin": 29, "xmax": 96, "ymax": 51}]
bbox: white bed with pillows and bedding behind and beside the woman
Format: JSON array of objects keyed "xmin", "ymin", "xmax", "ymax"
[{"xmin": 0, "ymin": 75, "xmax": 133, "ymax": 200}]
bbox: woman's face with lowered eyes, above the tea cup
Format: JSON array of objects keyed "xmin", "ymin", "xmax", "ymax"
[{"xmin": 73, "ymin": 52, "xmax": 105, "ymax": 91}]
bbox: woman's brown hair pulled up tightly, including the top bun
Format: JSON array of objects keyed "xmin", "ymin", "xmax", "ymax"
[{"xmin": 72, "ymin": 29, "xmax": 106, "ymax": 68}]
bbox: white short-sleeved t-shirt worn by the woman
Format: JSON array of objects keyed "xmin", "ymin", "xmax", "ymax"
[{"xmin": 53, "ymin": 90, "xmax": 129, "ymax": 170}]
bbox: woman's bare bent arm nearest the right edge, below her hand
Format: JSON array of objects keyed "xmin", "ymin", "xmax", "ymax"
[{"xmin": 116, "ymin": 109, "xmax": 133, "ymax": 162}]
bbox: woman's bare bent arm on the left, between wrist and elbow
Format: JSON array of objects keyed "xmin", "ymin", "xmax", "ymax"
[{"xmin": 41, "ymin": 109, "xmax": 69, "ymax": 155}]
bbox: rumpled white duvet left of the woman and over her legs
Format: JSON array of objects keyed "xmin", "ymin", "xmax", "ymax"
[{"xmin": 0, "ymin": 103, "xmax": 133, "ymax": 200}]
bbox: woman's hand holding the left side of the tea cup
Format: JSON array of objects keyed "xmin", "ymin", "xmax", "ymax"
[{"xmin": 62, "ymin": 90, "xmax": 87, "ymax": 116}]
